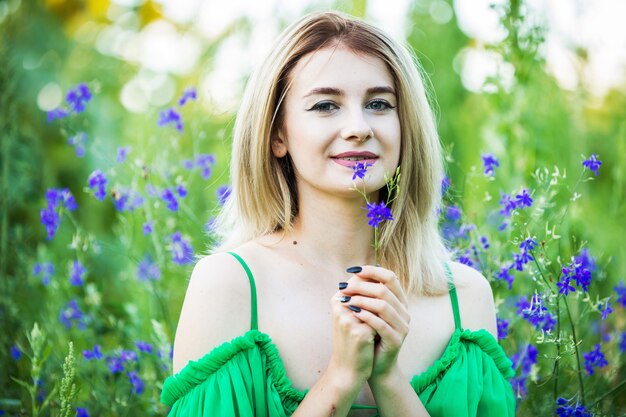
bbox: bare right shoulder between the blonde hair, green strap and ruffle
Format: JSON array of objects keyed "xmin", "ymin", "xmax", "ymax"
[{"xmin": 450, "ymin": 262, "xmax": 498, "ymax": 339}]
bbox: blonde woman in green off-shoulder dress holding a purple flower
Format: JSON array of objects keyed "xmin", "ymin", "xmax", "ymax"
[{"xmin": 162, "ymin": 13, "xmax": 515, "ymax": 417}]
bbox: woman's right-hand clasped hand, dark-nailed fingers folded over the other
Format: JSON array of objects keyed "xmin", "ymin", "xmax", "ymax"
[{"xmin": 340, "ymin": 265, "xmax": 411, "ymax": 379}]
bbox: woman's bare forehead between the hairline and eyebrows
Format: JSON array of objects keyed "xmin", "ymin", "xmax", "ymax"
[{"xmin": 291, "ymin": 45, "xmax": 394, "ymax": 93}]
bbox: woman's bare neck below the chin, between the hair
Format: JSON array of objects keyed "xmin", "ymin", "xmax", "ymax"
[{"xmin": 285, "ymin": 185, "xmax": 374, "ymax": 270}]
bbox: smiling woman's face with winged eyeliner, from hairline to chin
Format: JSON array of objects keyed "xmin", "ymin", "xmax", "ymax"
[{"xmin": 272, "ymin": 46, "xmax": 401, "ymax": 195}]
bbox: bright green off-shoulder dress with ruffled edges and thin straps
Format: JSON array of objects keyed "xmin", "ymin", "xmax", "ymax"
[{"xmin": 161, "ymin": 252, "xmax": 515, "ymax": 417}]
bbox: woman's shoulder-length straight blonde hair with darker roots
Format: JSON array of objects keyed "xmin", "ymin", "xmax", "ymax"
[{"xmin": 214, "ymin": 12, "xmax": 449, "ymax": 295}]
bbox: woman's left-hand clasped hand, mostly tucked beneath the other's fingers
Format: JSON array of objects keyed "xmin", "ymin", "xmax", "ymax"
[{"xmin": 328, "ymin": 284, "xmax": 376, "ymax": 391}]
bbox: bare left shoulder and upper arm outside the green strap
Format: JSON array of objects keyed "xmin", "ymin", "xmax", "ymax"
[{"xmin": 174, "ymin": 253, "xmax": 251, "ymax": 373}]
